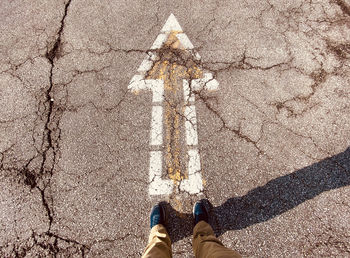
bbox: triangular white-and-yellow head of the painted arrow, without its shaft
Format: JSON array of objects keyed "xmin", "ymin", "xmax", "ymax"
[{"xmin": 128, "ymin": 14, "xmax": 219, "ymax": 96}]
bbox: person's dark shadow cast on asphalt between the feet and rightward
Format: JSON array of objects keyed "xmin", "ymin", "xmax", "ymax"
[{"xmin": 168, "ymin": 148, "xmax": 350, "ymax": 242}]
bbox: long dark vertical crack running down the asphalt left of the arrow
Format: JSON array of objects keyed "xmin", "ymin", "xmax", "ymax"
[{"xmin": 0, "ymin": 0, "xmax": 90, "ymax": 257}]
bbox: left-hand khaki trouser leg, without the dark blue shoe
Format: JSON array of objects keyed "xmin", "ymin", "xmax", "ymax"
[{"xmin": 142, "ymin": 224, "xmax": 172, "ymax": 258}]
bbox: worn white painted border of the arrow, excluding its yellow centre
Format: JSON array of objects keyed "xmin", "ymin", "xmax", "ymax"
[{"xmin": 128, "ymin": 14, "xmax": 219, "ymax": 195}]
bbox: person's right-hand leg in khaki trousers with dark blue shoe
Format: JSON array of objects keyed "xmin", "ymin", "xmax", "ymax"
[{"xmin": 192, "ymin": 200, "xmax": 241, "ymax": 258}]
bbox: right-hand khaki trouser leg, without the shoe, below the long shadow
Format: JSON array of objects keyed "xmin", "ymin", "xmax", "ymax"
[{"xmin": 193, "ymin": 221, "xmax": 241, "ymax": 258}]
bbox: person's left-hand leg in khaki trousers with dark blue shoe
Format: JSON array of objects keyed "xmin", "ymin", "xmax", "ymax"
[{"xmin": 142, "ymin": 203, "xmax": 172, "ymax": 258}]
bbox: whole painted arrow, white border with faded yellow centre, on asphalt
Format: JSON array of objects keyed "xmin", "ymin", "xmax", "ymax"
[{"xmin": 128, "ymin": 14, "xmax": 219, "ymax": 195}]
